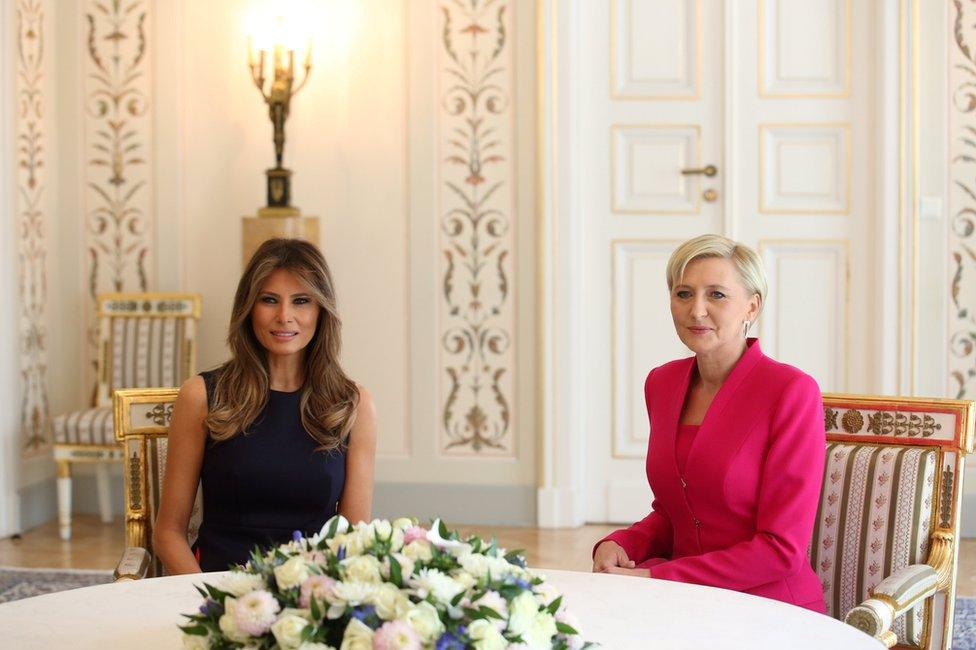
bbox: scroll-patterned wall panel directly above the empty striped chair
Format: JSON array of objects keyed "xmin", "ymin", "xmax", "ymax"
[{"xmin": 83, "ymin": 0, "xmax": 154, "ymax": 380}]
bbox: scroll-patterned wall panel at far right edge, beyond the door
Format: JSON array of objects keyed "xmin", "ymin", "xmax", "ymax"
[{"xmin": 948, "ymin": 0, "xmax": 976, "ymax": 399}]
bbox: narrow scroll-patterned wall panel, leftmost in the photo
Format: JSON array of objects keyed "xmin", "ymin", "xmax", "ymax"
[{"xmin": 15, "ymin": 0, "xmax": 52, "ymax": 456}]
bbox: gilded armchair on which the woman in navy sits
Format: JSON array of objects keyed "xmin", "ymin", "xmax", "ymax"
[{"xmin": 113, "ymin": 388, "xmax": 203, "ymax": 581}]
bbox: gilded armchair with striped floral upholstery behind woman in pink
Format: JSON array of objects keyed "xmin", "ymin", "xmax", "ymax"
[{"xmin": 810, "ymin": 394, "xmax": 976, "ymax": 649}]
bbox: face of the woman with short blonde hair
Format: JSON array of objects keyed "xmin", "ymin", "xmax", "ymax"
[{"xmin": 671, "ymin": 257, "xmax": 759, "ymax": 355}]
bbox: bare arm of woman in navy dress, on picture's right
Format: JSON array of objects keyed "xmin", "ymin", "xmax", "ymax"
[{"xmin": 339, "ymin": 386, "xmax": 376, "ymax": 523}]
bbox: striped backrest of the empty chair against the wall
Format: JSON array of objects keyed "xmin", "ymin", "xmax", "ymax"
[{"xmin": 94, "ymin": 293, "xmax": 200, "ymax": 406}]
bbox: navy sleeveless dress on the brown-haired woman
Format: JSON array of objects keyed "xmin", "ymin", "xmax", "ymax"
[{"xmin": 194, "ymin": 371, "xmax": 346, "ymax": 571}]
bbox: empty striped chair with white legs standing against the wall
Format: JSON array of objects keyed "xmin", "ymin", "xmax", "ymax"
[{"xmin": 51, "ymin": 293, "xmax": 200, "ymax": 539}]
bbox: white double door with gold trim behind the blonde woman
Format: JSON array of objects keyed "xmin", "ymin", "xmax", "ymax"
[{"xmin": 576, "ymin": 0, "xmax": 884, "ymax": 522}]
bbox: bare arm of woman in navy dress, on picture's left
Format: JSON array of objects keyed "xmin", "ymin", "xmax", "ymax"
[{"xmin": 153, "ymin": 376, "xmax": 207, "ymax": 574}]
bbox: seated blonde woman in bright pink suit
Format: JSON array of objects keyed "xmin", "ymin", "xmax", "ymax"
[{"xmin": 593, "ymin": 235, "xmax": 826, "ymax": 612}]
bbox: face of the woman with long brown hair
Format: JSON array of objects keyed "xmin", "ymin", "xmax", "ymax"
[{"xmin": 251, "ymin": 269, "xmax": 321, "ymax": 356}]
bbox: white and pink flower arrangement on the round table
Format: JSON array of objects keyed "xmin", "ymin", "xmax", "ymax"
[{"xmin": 181, "ymin": 516, "xmax": 593, "ymax": 650}]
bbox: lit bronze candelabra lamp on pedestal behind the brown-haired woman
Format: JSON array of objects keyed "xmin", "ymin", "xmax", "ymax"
[{"xmin": 241, "ymin": 18, "xmax": 319, "ymax": 266}]
